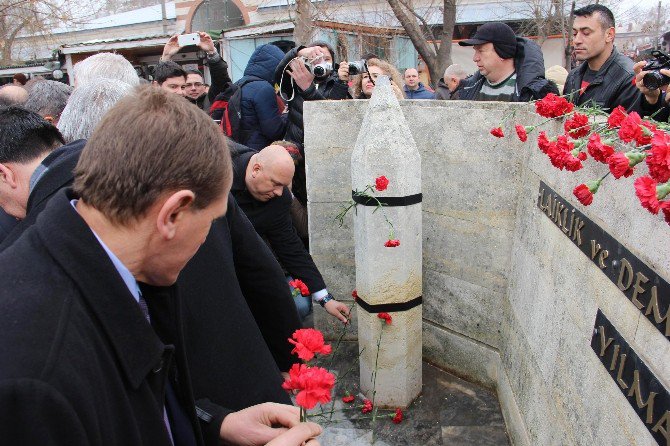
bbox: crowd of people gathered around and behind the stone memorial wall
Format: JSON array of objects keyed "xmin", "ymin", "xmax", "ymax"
[{"xmin": 0, "ymin": 4, "xmax": 670, "ymax": 446}]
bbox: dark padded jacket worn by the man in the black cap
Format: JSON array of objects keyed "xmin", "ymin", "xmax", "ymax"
[{"xmin": 458, "ymin": 37, "xmax": 559, "ymax": 102}]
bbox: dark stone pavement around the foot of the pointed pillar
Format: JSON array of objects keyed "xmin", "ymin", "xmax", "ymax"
[{"xmin": 310, "ymin": 342, "xmax": 510, "ymax": 446}]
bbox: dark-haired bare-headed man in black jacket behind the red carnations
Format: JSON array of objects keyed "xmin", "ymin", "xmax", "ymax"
[{"xmin": 563, "ymin": 4, "xmax": 641, "ymax": 111}]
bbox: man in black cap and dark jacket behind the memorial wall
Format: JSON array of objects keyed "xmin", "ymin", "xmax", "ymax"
[{"xmin": 458, "ymin": 22, "xmax": 558, "ymax": 102}]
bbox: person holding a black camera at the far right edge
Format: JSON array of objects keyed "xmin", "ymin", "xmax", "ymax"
[{"xmin": 633, "ymin": 57, "xmax": 670, "ymax": 121}]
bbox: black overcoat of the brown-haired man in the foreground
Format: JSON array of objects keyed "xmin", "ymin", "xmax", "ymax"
[{"xmin": 0, "ymin": 191, "xmax": 215, "ymax": 446}]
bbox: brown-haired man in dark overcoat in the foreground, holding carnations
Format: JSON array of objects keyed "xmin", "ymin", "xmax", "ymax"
[{"xmin": 0, "ymin": 88, "xmax": 320, "ymax": 445}]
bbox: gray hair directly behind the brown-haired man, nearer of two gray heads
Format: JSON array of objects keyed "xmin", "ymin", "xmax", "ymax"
[{"xmin": 58, "ymin": 79, "xmax": 133, "ymax": 143}]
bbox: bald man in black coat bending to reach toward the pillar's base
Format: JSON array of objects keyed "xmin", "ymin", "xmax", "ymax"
[{"xmin": 231, "ymin": 145, "xmax": 349, "ymax": 323}]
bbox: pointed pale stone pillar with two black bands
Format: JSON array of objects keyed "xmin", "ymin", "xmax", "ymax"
[{"xmin": 351, "ymin": 76, "xmax": 422, "ymax": 407}]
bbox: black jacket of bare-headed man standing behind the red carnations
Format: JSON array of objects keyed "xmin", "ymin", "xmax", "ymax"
[{"xmin": 563, "ymin": 48, "xmax": 642, "ymax": 112}]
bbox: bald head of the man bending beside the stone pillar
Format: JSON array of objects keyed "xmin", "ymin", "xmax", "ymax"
[{"xmin": 245, "ymin": 145, "xmax": 295, "ymax": 201}]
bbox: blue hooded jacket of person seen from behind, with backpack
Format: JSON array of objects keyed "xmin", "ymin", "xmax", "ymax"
[{"xmin": 236, "ymin": 44, "xmax": 287, "ymax": 150}]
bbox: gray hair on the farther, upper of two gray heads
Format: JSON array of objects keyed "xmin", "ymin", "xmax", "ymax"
[{"xmin": 74, "ymin": 53, "xmax": 140, "ymax": 87}]
